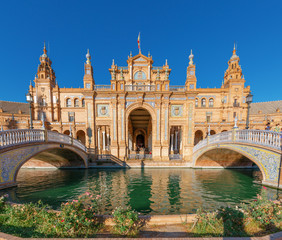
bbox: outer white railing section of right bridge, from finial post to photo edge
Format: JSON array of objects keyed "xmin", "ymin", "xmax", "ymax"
[{"xmin": 236, "ymin": 130, "xmax": 282, "ymax": 150}]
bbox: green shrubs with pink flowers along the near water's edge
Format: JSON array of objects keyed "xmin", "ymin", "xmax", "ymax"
[{"xmin": 0, "ymin": 189, "xmax": 282, "ymax": 238}]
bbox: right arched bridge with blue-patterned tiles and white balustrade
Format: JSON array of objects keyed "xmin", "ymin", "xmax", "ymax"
[{"xmin": 193, "ymin": 129, "xmax": 282, "ymax": 188}]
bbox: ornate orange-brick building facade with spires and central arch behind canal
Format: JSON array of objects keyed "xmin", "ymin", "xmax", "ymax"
[{"xmin": 0, "ymin": 47, "xmax": 280, "ymax": 161}]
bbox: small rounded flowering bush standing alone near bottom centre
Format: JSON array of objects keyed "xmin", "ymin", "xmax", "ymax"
[{"xmin": 113, "ymin": 207, "xmax": 140, "ymax": 236}]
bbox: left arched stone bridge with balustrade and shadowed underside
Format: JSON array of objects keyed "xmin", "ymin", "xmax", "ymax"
[{"xmin": 0, "ymin": 129, "xmax": 88, "ymax": 189}]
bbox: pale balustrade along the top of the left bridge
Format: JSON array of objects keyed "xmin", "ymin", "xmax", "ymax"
[{"xmin": 0, "ymin": 129, "xmax": 86, "ymax": 152}]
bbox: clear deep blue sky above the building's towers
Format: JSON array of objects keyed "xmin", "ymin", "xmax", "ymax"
[{"xmin": 0, "ymin": 0, "xmax": 282, "ymax": 102}]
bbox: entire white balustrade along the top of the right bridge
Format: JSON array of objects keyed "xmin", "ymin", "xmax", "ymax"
[{"xmin": 193, "ymin": 129, "xmax": 282, "ymax": 152}]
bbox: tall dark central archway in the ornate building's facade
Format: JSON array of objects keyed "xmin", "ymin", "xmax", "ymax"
[{"xmin": 128, "ymin": 108, "xmax": 152, "ymax": 156}]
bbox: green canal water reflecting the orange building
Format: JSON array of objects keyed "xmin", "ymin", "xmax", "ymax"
[{"xmin": 0, "ymin": 169, "xmax": 282, "ymax": 214}]
